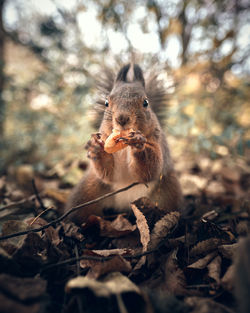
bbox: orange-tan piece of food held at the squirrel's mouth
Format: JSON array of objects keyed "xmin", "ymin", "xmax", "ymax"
[{"xmin": 104, "ymin": 129, "xmax": 133, "ymax": 153}]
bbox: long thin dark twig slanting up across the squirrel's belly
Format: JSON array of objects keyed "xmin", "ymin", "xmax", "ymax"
[{"xmin": 0, "ymin": 182, "xmax": 140, "ymax": 241}]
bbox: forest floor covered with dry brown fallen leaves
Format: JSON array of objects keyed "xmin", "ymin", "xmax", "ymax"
[{"xmin": 0, "ymin": 156, "xmax": 250, "ymax": 313}]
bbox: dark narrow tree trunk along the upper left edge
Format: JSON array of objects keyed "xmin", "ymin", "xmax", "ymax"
[{"xmin": 0, "ymin": 0, "xmax": 5, "ymax": 142}]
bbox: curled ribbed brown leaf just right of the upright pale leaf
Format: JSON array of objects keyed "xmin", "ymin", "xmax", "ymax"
[{"xmin": 149, "ymin": 212, "xmax": 180, "ymax": 249}]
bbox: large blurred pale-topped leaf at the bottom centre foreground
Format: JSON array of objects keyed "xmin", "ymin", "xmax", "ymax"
[{"xmin": 65, "ymin": 272, "xmax": 146, "ymax": 313}]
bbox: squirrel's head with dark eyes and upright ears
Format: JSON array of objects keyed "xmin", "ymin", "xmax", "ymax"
[{"xmin": 101, "ymin": 64, "xmax": 152, "ymax": 131}]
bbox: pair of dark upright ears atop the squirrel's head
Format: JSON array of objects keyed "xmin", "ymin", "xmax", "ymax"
[{"xmin": 116, "ymin": 64, "xmax": 145, "ymax": 87}]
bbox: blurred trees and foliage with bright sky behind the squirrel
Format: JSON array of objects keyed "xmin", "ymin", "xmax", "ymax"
[{"xmin": 0, "ymin": 0, "xmax": 250, "ymax": 172}]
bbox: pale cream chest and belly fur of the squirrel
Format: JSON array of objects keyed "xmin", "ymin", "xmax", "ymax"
[{"xmin": 112, "ymin": 147, "xmax": 156, "ymax": 210}]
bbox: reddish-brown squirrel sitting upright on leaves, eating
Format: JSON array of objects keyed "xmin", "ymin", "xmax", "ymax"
[{"xmin": 65, "ymin": 64, "xmax": 182, "ymax": 224}]
